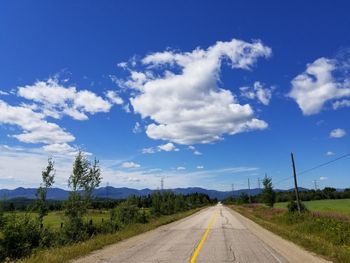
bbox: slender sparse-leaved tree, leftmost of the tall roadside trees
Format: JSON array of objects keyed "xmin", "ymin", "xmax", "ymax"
[{"xmin": 36, "ymin": 158, "xmax": 55, "ymax": 225}]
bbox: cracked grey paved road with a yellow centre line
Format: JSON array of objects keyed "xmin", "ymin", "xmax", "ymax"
[{"xmin": 75, "ymin": 204, "xmax": 327, "ymax": 263}]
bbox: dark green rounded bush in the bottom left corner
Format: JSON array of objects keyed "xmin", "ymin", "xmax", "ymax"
[{"xmin": 1, "ymin": 215, "xmax": 41, "ymax": 260}]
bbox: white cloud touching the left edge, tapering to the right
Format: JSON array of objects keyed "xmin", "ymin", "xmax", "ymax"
[{"xmin": 0, "ymin": 100, "xmax": 75, "ymax": 144}]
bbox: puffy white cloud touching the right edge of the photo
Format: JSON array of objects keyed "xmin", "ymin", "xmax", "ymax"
[{"xmin": 288, "ymin": 57, "xmax": 350, "ymax": 115}]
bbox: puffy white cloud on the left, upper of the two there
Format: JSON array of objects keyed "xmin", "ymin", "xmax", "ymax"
[{"xmin": 17, "ymin": 78, "xmax": 112, "ymax": 120}]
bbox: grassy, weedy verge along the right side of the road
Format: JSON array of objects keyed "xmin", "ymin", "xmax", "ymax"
[{"xmin": 230, "ymin": 205, "xmax": 350, "ymax": 262}]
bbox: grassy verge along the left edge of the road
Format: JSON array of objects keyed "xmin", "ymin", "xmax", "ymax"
[{"xmin": 18, "ymin": 207, "xmax": 204, "ymax": 263}]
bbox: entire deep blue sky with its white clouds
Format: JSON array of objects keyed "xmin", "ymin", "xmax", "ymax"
[{"xmin": 0, "ymin": 1, "xmax": 350, "ymax": 190}]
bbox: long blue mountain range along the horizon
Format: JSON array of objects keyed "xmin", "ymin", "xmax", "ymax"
[{"xmin": 0, "ymin": 186, "xmax": 308, "ymax": 200}]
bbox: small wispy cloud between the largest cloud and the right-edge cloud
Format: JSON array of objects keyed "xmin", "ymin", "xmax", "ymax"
[{"xmin": 240, "ymin": 81, "xmax": 273, "ymax": 106}]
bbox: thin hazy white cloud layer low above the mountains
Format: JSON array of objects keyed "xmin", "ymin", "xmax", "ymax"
[{"xmin": 0, "ymin": 145, "xmax": 257, "ymax": 190}]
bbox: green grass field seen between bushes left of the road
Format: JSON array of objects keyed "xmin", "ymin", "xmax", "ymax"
[{"xmin": 5, "ymin": 210, "xmax": 110, "ymax": 229}]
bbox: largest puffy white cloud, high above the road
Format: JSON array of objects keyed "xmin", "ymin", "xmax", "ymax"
[{"xmin": 119, "ymin": 39, "xmax": 271, "ymax": 144}]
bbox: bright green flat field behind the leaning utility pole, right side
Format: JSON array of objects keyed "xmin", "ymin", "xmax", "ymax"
[{"xmin": 275, "ymin": 199, "xmax": 350, "ymax": 215}]
